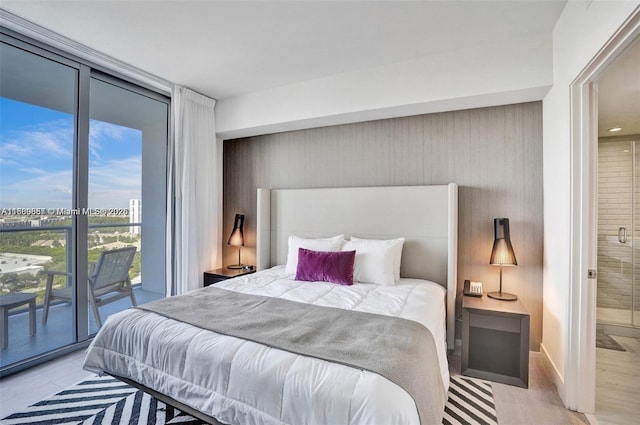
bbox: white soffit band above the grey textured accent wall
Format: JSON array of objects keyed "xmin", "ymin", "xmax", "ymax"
[{"xmin": 216, "ymin": 36, "xmax": 552, "ymax": 139}]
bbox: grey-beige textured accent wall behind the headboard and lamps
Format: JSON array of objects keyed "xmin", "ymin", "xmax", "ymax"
[{"xmin": 222, "ymin": 102, "xmax": 543, "ymax": 351}]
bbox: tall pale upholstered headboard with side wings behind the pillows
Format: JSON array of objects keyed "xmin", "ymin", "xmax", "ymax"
[{"xmin": 256, "ymin": 183, "xmax": 458, "ymax": 349}]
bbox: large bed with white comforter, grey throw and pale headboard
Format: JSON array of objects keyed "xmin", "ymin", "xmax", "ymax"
[{"xmin": 85, "ymin": 184, "xmax": 457, "ymax": 424}]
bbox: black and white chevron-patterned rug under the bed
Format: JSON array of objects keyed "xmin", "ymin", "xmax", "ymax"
[{"xmin": 0, "ymin": 376, "xmax": 498, "ymax": 425}]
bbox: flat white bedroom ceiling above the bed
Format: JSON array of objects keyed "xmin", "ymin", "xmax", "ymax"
[{"xmin": 2, "ymin": 0, "xmax": 566, "ymax": 99}]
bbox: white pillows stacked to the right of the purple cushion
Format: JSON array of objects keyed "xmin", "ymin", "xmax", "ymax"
[{"xmin": 342, "ymin": 238, "xmax": 404, "ymax": 285}]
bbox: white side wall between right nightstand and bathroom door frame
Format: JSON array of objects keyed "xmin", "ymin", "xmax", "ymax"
[{"xmin": 542, "ymin": 0, "xmax": 640, "ymax": 407}]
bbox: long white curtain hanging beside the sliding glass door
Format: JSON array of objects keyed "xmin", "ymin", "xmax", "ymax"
[{"xmin": 167, "ymin": 86, "xmax": 222, "ymax": 294}]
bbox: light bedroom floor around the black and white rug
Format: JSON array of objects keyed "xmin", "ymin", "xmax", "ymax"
[{"xmin": 0, "ymin": 350, "xmax": 608, "ymax": 425}]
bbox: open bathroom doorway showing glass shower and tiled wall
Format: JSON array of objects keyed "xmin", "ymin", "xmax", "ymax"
[{"xmin": 595, "ymin": 34, "xmax": 640, "ymax": 425}]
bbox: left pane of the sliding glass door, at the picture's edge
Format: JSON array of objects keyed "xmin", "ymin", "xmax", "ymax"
[{"xmin": 0, "ymin": 39, "xmax": 79, "ymax": 367}]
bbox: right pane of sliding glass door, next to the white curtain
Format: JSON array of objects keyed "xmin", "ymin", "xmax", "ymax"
[{"xmin": 87, "ymin": 75, "xmax": 169, "ymax": 333}]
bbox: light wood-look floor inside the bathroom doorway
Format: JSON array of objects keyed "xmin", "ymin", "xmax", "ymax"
[{"xmin": 595, "ymin": 336, "xmax": 640, "ymax": 425}]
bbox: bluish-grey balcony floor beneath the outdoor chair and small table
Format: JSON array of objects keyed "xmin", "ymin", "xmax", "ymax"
[{"xmin": 0, "ymin": 287, "xmax": 164, "ymax": 368}]
